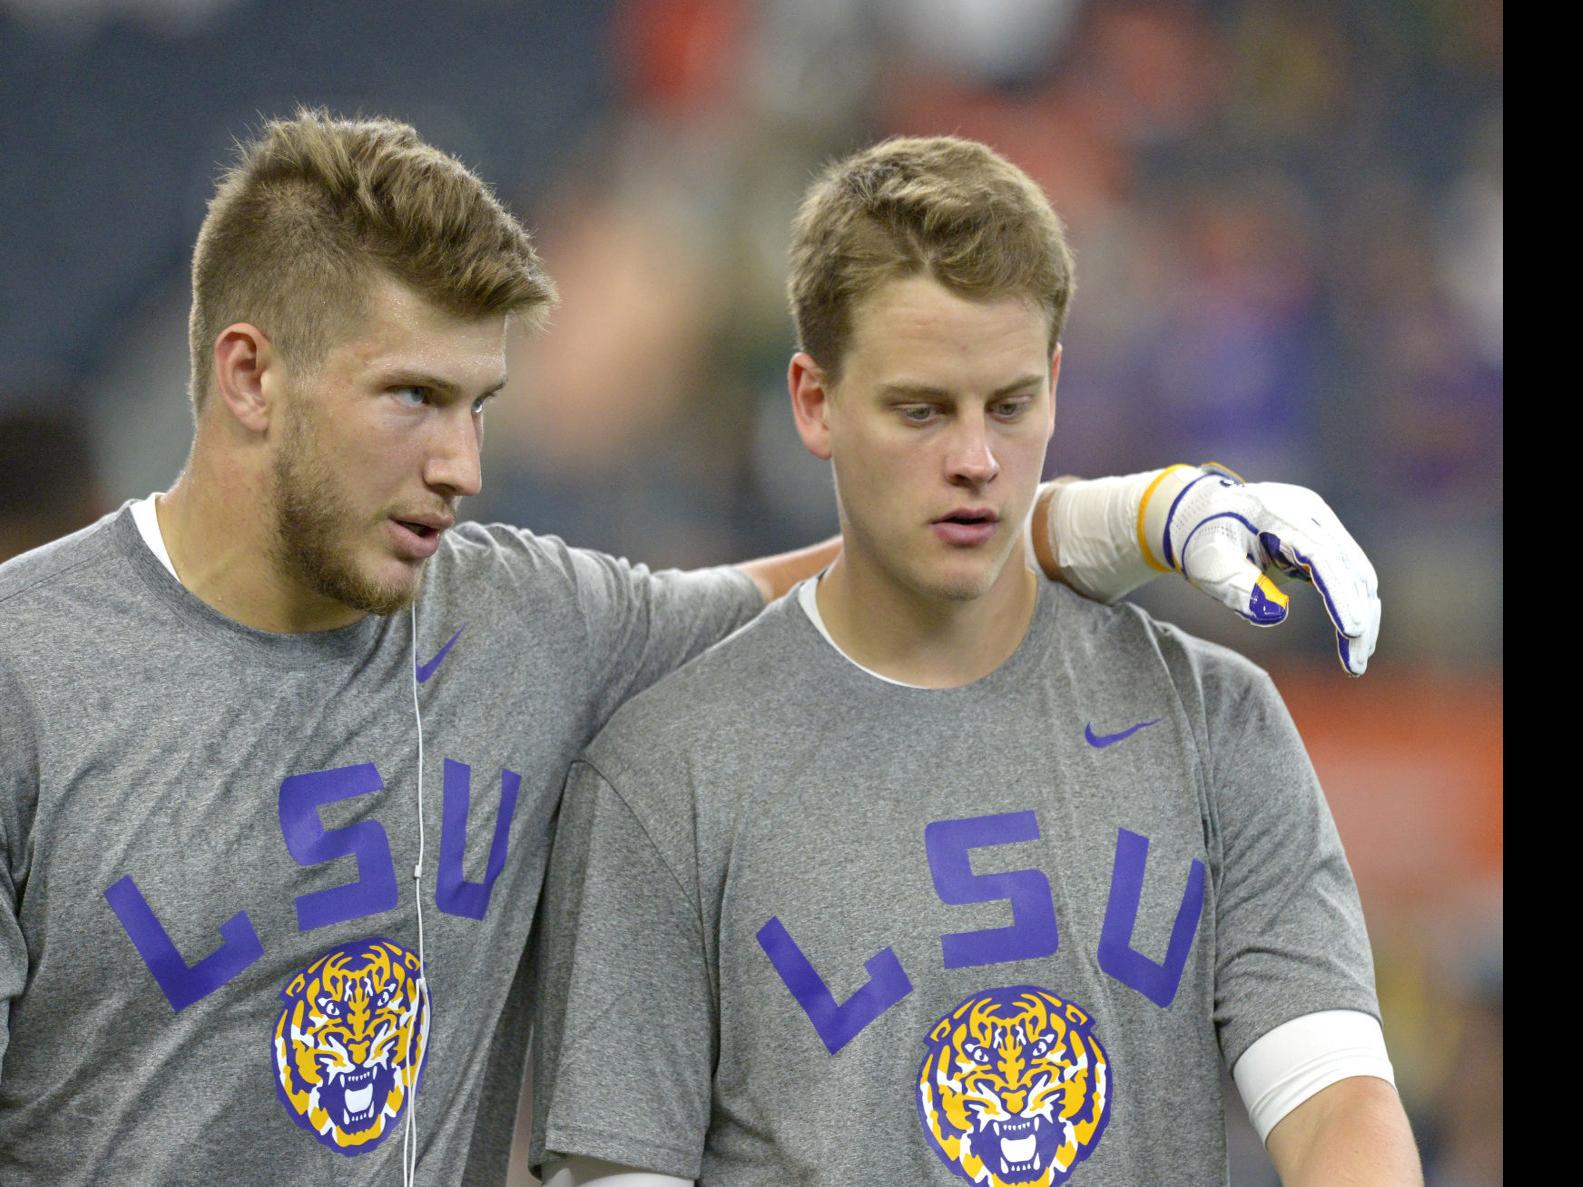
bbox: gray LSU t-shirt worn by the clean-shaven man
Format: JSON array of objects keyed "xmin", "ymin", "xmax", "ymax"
[{"xmin": 533, "ymin": 586, "xmax": 1379, "ymax": 1187}]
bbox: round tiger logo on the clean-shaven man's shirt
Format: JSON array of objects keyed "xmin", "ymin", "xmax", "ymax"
[{"xmin": 918, "ymin": 986, "xmax": 1111, "ymax": 1187}]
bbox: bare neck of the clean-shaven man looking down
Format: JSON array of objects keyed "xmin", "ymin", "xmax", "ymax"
[{"xmin": 815, "ymin": 549, "xmax": 1038, "ymax": 688}]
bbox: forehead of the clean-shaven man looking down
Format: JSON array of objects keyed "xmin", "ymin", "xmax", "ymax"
[{"xmin": 844, "ymin": 275, "xmax": 1050, "ymax": 391}]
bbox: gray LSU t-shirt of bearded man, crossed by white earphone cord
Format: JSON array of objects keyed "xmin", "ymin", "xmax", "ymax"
[{"xmin": 0, "ymin": 508, "xmax": 761, "ymax": 1187}]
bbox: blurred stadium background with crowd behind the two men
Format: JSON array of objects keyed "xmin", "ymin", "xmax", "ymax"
[{"xmin": 0, "ymin": 0, "xmax": 1504, "ymax": 1187}]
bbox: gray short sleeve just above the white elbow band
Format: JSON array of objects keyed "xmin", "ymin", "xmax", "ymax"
[{"xmin": 1209, "ymin": 669, "xmax": 1379, "ymax": 1065}]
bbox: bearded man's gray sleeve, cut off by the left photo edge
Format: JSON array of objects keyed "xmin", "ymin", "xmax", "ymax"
[{"xmin": 0, "ymin": 660, "xmax": 38, "ymax": 1081}]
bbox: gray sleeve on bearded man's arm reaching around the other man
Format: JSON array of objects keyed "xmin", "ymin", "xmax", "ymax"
[{"xmin": 568, "ymin": 548, "xmax": 765, "ymax": 731}]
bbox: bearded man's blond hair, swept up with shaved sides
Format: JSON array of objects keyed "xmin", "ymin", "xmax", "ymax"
[{"xmin": 188, "ymin": 108, "xmax": 556, "ymax": 408}]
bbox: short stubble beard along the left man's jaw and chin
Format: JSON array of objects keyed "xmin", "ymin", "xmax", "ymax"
[{"xmin": 272, "ymin": 397, "xmax": 423, "ymax": 614}]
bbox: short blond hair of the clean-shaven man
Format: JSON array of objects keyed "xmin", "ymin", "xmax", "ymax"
[{"xmin": 787, "ymin": 136, "xmax": 1073, "ymax": 380}]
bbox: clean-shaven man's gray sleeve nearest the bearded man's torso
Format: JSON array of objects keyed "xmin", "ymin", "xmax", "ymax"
[{"xmin": 529, "ymin": 761, "xmax": 717, "ymax": 1179}]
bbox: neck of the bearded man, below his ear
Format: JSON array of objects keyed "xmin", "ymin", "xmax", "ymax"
[{"xmin": 154, "ymin": 430, "xmax": 363, "ymax": 633}]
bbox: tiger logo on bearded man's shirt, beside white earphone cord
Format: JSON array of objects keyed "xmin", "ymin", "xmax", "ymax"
[{"xmin": 275, "ymin": 937, "xmax": 429, "ymax": 1155}]
